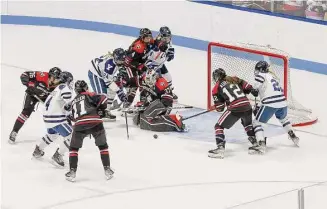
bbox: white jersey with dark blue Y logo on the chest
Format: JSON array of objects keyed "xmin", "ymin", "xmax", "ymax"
[{"xmin": 90, "ymin": 53, "xmax": 119, "ymax": 86}]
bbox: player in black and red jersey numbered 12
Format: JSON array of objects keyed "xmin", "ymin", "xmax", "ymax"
[{"xmin": 209, "ymin": 68, "xmax": 259, "ymax": 158}]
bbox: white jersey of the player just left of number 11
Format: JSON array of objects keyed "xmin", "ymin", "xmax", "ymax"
[{"xmin": 43, "ymin": 84, "xmax": 73, "ymax": 128}]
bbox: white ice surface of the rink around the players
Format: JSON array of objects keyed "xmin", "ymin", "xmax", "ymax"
[{"xmin": 1, "ymin": 22, "xmax": 327, "ymax": 209}]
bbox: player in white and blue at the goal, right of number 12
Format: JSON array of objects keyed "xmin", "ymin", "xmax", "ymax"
[{"xmin": 253, "ymin": 61, "xmax": 299, "ymax": 153}]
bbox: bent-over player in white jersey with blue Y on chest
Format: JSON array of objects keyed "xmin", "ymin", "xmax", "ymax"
[{"xmin": 88, "ymin": 48, "xmax": 127, "ymax": 120}]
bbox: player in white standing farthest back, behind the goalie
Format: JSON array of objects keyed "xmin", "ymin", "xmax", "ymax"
[{"xmin": 145, "ymin": 26, "xmax": 177, "ymax": 99}]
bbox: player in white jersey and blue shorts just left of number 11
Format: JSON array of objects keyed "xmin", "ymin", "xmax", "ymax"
[{"xmin": 33, "ymin": 71, "xmax": 73, "ymax": 167}]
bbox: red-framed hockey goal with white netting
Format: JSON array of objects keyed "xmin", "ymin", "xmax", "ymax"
[{"xmin": 207, "ymin": 42, "xmax": 317, "ymax": 126}]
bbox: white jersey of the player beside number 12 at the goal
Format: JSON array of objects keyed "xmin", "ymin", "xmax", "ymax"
[{"xmin": 253, "ymin": 73, "xmax": 287, "ymax": 108}]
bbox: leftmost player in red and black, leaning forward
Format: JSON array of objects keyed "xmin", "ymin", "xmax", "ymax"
[{"xmin": 9, "ymin": 67, "xmax": 61, "ymax": 144}]
